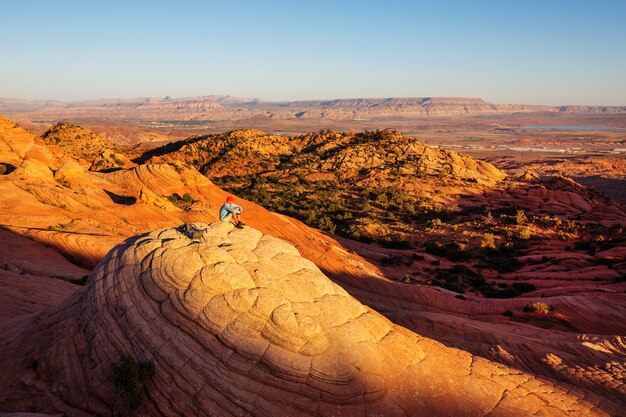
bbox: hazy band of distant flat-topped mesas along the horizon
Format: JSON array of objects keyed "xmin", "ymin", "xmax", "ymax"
[{"xmin": 0, "ymin": 95, "xmax": 626, "ymax": 121}]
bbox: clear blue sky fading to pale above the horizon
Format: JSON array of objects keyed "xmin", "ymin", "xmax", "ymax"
[{"xmin": 0, "ymin": 0, "xmax": 626, "ymax": 105}]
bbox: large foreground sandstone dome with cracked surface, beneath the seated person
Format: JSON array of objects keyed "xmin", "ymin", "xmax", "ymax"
[{"xmin": 0, "ymin": 223, "xmax": 616, "ymax": 416}]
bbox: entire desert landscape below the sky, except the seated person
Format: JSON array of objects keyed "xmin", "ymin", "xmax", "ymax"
[{"xmin": 0, "ymin": 92, "xmax": 626, "ymax": 417}]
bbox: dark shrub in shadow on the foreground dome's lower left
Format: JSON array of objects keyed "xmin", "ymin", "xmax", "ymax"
[{"xmin": 111, "ymin": 355, "xmax": 155, "ymax": 415}]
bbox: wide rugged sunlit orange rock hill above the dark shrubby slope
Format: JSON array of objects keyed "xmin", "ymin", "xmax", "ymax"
[{"xmin": 141, "ymin": 130, "xmax": 506, "ymax": 188}]
